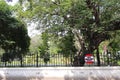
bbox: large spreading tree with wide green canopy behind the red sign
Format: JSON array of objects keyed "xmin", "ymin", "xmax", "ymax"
[{"xmin": 12, "ymin": 0, "xmax": 120, "ymax": 66}]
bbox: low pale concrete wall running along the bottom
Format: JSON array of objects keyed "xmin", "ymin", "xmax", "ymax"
[{"xmin": 0, "ymin": 67, "xmax": 120, "ymax": 80}]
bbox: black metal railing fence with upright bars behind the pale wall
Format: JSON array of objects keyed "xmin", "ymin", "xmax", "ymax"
[{"xmin": 0, "ymin": 54, "xmax": 120, "ymax": 67}]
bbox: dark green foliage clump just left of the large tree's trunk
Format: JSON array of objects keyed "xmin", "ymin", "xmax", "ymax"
[{"xmin": 60, "ymin": 32, "xmax": 76, "ymax": 57}]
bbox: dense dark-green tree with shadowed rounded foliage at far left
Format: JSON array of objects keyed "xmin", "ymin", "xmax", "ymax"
[{"xmin": 0, "ymin": 0, "xmax": 30, "ymax": 62}]
